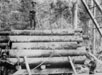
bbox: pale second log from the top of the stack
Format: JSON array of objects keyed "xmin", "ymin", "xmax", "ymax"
[{"xmin": 9, "ymin": 35, "xmax": 83, "ymax": 42}]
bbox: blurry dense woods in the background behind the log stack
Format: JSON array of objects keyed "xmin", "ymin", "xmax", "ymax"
[{"xmin": 0, "ymin": 0, "xmax": 89, "ymax": 30}]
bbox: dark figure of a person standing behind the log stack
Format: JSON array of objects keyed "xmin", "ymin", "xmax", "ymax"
[{"xmin": 29, "ymin": 2, "xmax": 36, "ymax": 29}]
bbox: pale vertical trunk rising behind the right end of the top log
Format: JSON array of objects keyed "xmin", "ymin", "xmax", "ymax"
[{"xmin": 72, "ymin": 0, "xmax": 78, "ymax": 29}]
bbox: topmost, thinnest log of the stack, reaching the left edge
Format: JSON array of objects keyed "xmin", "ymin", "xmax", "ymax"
[{"xmin": 0, "ymin": 29, "xmax": 82, "ymax": 35}]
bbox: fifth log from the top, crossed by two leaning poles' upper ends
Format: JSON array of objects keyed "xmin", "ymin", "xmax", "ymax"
[{"xmin": 8, "ymin": 56, "xmax": 86, "ymax": 65}]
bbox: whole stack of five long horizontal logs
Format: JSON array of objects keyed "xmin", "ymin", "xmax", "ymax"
[{"xmin": 0, "ymin": 30, "xmax": 86, "ymax": 73}]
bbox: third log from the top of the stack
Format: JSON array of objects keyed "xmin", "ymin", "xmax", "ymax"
[{"xmin": 12, "ymin": 42, "xmax": 81, "ymax": 49}]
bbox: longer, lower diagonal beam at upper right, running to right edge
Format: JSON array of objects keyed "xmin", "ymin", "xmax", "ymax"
[{"xmin": 81, "ymin": 0, "xmax": 102, "ymax": 37}]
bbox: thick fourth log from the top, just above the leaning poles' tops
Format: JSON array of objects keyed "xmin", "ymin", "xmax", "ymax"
[{"xmin": 9, "ymin": 48, "xmax": 86, "ymax": 57}]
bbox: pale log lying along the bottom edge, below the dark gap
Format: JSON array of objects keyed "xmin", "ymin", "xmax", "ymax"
[{"xmin": 14, "ymin": 68, "xmax": 73, "ymax": 75}]
